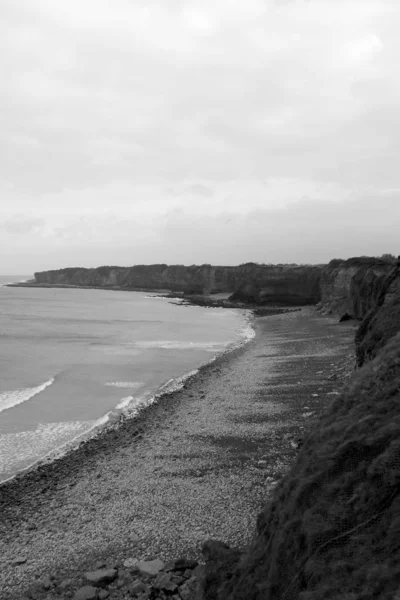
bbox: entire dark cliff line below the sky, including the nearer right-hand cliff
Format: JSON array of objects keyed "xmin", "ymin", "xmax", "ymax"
[{"xmin": 35, "ymin": 257, "xmax": 394, "ymax": 319}]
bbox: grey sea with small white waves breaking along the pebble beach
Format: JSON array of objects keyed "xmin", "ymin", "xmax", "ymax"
[{"xmin": 0, "ymin": 276, "xmax": 253, "ymax": 482}]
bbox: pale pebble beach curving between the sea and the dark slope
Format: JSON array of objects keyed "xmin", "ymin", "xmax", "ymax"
[{"xmin": 0, "ymin": 309, "xmax": 354, "ymax": 599}]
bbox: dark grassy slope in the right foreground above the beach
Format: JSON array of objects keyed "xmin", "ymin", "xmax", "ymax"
[{"xmin": 204, "ymin": 335, "xmax": 400, "ymax": 600}]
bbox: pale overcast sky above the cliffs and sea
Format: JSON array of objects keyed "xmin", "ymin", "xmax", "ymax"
[{"xmin": 0, "ymin": 0, "xmax": 400, "ymax": 274}]
